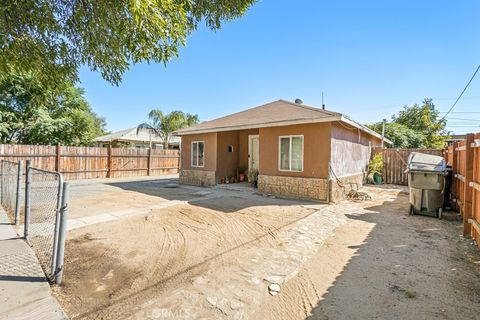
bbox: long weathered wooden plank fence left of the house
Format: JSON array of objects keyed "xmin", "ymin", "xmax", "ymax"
[{"xmin": 0, "ymin": 144, "xmax": 180, "ymax": 180}]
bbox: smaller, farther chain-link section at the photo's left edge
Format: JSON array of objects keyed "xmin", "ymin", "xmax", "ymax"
[{"xmin": 0, "ymin": 160, "xmax": 22, "ymax": 224}]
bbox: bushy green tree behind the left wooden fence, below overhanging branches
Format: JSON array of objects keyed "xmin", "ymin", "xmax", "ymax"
[{"xmin": 0, "ymin": 72, "xmax": 105, "ymax": 145}]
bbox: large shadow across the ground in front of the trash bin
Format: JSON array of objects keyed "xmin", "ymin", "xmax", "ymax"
[{"xmin": 307, "ymin": 193, "xmax": 480, "ymax": 320}]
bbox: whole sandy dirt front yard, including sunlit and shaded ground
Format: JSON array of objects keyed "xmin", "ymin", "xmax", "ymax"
[{"xmin": 50, "ymin": 180, "xmax": 480, "ymax": 320}]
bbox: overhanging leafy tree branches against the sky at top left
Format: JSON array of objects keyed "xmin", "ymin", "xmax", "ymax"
[{"xmin": 0, "ymin": 0, "xmax": 255, "ymax": 84}]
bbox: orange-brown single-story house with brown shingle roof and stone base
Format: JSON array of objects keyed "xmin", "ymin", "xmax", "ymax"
[{"xmin": 175, "ymin": 100, "xmax": 391, "ymax": 201}]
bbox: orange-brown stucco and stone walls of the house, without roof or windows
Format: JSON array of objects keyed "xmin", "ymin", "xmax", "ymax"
[{"xmin": 180, "ymin": 122, "xmax": 381, "ymax": 201}]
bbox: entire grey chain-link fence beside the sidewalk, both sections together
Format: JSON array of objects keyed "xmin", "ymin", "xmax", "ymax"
[{"xmin": 0, "ymin": 160, "xmax": 68, "ymax": 284}]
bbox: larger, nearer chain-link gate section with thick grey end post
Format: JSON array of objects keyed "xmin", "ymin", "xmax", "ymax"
[{"xmin": 24, "ymin": 162, "xmax": 68, "ymax": 283}]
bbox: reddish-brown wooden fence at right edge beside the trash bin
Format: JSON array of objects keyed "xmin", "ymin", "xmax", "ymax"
[{"xmin": 445, "ymin": 133, "xmax": 480, "ymax": 246}]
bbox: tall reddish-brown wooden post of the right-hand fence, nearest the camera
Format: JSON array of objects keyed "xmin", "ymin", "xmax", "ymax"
[{"xmin": 463, "ymin": 133, "xmax": 475, "ymax": 236}]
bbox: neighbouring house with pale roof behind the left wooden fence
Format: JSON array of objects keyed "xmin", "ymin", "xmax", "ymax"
[{"xmin": 94, "ymin": 127, "xmax": 180, "ymax": 149}]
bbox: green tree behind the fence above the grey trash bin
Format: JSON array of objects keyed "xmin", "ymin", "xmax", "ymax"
[{"xmin": 367, "ymin": 99, "xmax": 447, "ymax": 148}]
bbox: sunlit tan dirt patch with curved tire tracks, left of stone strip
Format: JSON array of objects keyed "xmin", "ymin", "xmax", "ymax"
[{"xmin": 57, "ymin": 195, "xmax": 318, "ymax": 319}]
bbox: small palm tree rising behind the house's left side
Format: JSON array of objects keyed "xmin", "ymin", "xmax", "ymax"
[{"xmin": 137, "ymin": 109, "xmax": 199, "ymax": 149}]
